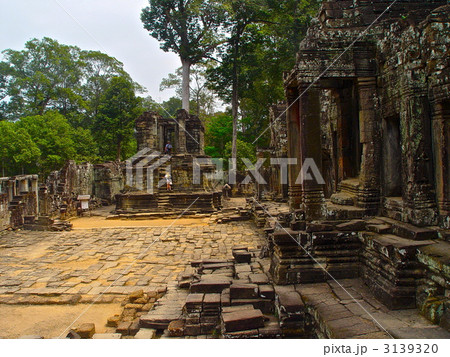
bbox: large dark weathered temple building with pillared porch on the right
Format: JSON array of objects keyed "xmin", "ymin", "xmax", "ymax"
[{"xmin": 262, "ymin": 1, "xmax": 450, "ymax": 326}]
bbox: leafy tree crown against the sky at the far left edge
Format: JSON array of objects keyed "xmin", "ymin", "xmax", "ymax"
[{"xmin": 0, "ymin": 37, "xmax": 83, "ymax": 119}]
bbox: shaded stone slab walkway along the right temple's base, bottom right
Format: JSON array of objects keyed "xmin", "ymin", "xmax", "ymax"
[{"xmin": 296, "ymin": 279, "xmax": 450, "ymax": 339}]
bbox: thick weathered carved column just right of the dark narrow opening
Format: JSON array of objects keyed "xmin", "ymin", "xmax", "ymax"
[{"xmin": 400, "ymin": 86, "xmax": 436, "ymax": 226}]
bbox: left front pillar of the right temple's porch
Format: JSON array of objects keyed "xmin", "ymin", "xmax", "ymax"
[{"xmin": 298, "ymin": 84, "xmax": 325, "ymax": 220}]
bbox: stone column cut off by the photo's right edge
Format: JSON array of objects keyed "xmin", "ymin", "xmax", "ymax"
[{"xmin": 432, "ymin": 103, "xmax": 450, "ymax": 228}]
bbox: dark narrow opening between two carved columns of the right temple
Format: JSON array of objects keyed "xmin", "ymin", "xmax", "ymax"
[{"xmin": 382, "ymin": 115, "xmax": 402, "ymax": 197}]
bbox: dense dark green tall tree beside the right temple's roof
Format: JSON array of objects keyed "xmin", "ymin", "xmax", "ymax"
[{"xmin": 207, "ymin": 0, "xmax": 320, "ymax": 147}]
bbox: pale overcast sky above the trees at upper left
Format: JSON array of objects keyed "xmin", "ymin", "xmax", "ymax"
[{"xmin": 0, "ymin": 0, "xmax": 181, "ymax": 101}]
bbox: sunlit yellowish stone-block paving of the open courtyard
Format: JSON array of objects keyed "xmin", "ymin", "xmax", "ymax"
[{"xmin": 0, "ymin": 220, "xmax": 264, "ymax": 304}]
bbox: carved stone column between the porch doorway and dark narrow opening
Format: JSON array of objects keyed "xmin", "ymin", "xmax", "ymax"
[{"xmin": 357, "ymin": 77, "xmax": 381, "ymax": 214}]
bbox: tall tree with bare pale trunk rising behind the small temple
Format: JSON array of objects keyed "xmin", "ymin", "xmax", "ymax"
[{"xmin": 141, "ymin": 0, "xmax": 225, "ymax": 112}]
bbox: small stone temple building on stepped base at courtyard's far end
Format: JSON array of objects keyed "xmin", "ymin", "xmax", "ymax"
[{"xmin": 116, "ymin": 110, "xmax": 221, "ymax": 217}]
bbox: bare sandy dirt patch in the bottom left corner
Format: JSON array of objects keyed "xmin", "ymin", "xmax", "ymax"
[{"xmin": 0, "ymin": 304, "xmax": 121, "ymax": 338}]
